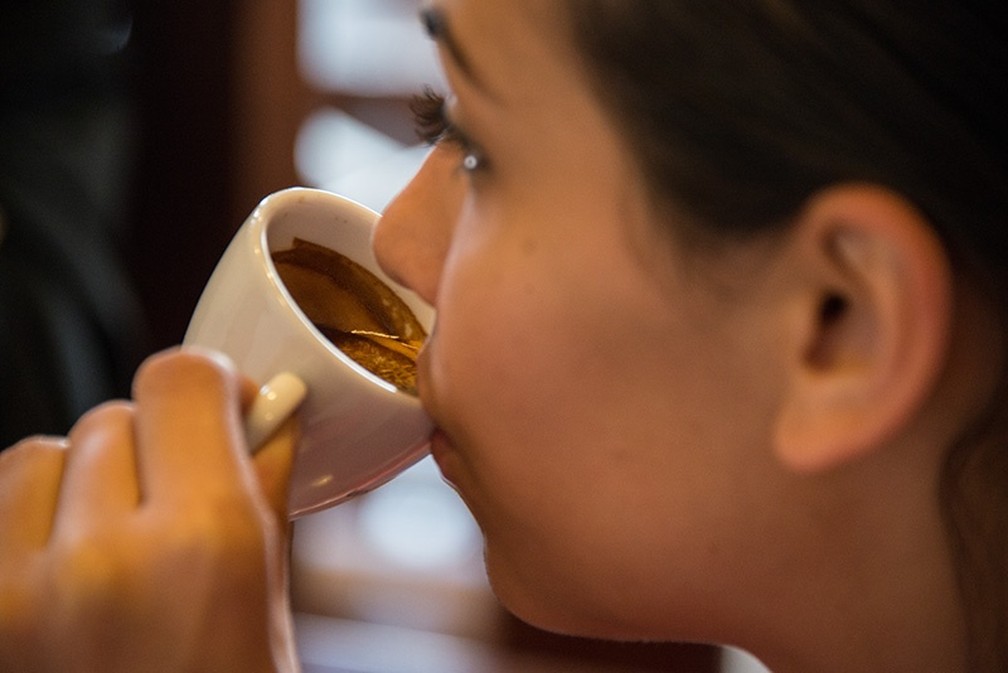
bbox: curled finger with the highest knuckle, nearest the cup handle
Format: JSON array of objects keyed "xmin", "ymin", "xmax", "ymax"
[{"xmin": 133, "ymin": 350, "xmax": 252, "ymax": 501}]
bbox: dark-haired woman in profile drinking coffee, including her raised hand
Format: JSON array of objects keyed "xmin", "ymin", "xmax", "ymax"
[{"xmin": 0, "ymin": 0, "xmax": 1008, "ymax": 673}]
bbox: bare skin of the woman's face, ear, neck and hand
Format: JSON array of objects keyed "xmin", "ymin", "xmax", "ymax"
[{"xmin": 0, "ymin": 0, "xmax": 1001, "ymax": 673}]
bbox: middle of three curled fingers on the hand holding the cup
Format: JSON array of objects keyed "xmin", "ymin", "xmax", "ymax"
[{"xmin": 54, "ymin": 402, "xmax": 140, "ymax": 535}]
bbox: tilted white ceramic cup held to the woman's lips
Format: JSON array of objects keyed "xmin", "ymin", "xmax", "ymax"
[{"xmin": 183, "ymin": 187, "xmax": 433, "ymax": 518}]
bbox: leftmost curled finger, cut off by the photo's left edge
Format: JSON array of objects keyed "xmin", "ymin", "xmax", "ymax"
[{"xmin": 0, "ymin": 437, "xmax": 67, "ymax": 556}]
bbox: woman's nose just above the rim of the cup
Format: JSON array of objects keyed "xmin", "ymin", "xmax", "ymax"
[{"xmin": 371, "ymin": 147, "xmax": 465, "ymax": 304}]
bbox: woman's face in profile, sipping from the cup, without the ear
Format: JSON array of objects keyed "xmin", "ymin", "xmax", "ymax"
[{"xmin": 374, "ymin": 0, "xmax": 786, "ymax": 638}]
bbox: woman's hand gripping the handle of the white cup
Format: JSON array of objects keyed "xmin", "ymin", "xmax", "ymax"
[{"xmin": 0, "ymin": 351, "xmax": 297, "ymax": 673}]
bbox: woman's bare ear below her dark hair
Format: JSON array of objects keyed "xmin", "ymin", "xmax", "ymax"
[{"xmin": 774, "ymin": 184, "xmax": 953, "ymax": 470}]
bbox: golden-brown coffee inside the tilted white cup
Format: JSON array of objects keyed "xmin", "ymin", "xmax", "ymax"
[{"xmin": 272, "ymin": 239, "xmax": 426, "ymax": 395}]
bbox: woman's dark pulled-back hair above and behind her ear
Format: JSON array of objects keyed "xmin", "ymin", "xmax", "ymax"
[{"xmin": 568, "ymin": 0, "xmax": 1008, "ymax": 672}]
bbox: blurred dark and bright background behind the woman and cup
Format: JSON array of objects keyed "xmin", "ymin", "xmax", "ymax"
[{"xmin": 0, "ymin": 0, "xmax": 761, "ymax": 673}]
